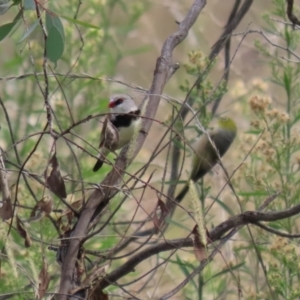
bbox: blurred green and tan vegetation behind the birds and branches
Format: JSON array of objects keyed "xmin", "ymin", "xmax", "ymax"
[{"xmin": 0, "ymin": 0, "xmax": 300, "ymax": 300}]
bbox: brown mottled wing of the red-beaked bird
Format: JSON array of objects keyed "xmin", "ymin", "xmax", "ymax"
[{"xmin": 99, "ymin": 116, "xmax": 119, "ymax": 151}]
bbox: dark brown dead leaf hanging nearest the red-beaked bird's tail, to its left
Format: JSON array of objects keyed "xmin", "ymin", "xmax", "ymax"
[{"xmin": 45, "ymin": 153, "xmax": 67, "ymax": 198}]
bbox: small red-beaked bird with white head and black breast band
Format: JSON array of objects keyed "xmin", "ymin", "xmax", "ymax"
[{"xmin": 93, "ymin": 94, "xmax": 140, "ymax": 172}]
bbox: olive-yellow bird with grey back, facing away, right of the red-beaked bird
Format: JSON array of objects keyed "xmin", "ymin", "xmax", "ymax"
[{"xmin": 176, "ymin": 117, "xmax": 237, "ymax": 202}]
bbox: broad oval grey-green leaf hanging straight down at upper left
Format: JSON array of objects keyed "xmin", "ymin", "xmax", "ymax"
[{"xmin": 46, "ymin": 13, "xmax": 65, "ymax": 64}]
